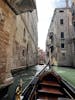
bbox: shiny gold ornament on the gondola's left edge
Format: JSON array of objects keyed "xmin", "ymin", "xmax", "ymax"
[{"xmin": 15, "ymin": 79, "xmax": 23, "ymax": 100}]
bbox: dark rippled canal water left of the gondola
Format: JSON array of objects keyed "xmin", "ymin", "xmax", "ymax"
[{"xmin": 7, "ymin": 65, "xmax": 45, "ymax": 100}]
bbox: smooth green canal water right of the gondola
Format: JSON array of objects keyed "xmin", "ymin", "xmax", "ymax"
[{"xmin": 53, "ymin": 66, "xmax": 75, "ymax": 87}]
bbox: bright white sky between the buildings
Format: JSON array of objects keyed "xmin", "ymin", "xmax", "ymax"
[{"xmin": 36, "ymin": 0, "xmax": 70, "ymax": 51}]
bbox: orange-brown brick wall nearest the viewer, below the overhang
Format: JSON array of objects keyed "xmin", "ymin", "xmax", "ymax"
[{"xmin": 0, "ymin": 0, "xmax": 16, "ymax": 83}]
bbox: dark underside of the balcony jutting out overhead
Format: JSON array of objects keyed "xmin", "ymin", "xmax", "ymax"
[{"xmin": 4, "ymin": 0, "xmax": 36, "ymax": 15}]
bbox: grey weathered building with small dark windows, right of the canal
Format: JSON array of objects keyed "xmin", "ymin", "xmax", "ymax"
[{"xmin": 46, "ymin": 5, "xmax": 73, "ymax": 66}]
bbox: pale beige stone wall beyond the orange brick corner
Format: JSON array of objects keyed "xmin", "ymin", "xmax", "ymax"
[{"xmin": 12, "ymin": 10, "xmax": 38, "ymax": 70}]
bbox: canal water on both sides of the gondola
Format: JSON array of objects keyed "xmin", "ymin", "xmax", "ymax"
[{"xmin": 7, "ymin": 65, "xmax": 75, "ymax": 100}]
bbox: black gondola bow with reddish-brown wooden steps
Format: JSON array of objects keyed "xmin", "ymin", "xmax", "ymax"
[{"xmin": 22, "ymin": 66, "xmax": 75, "ymax": 100}]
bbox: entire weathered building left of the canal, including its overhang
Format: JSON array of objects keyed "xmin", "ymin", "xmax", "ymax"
[{"xmin": 0, "ymin": 0, "xmax": 38, "ymax": 93}]
